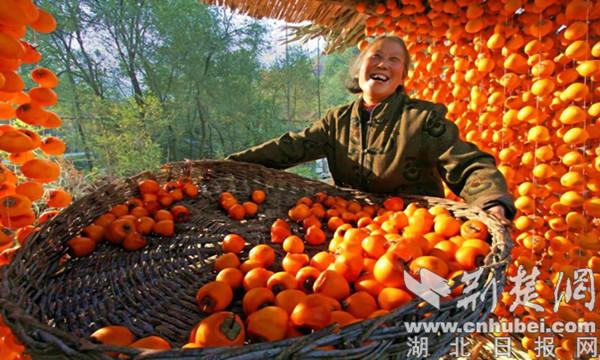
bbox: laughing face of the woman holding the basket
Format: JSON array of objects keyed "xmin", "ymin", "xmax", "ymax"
[{"xmin": 358, "ymin": 39, "xmax": 405, "ymax": 104}]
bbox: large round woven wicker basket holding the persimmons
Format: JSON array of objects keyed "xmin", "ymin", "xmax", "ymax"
[{"xmin": 0, "ymin": 161, "xmax": 512, "ymax": 359}]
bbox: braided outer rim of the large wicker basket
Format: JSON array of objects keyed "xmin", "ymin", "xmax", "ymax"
[{"xmin": 0, "ymin": 160, "xmax": 512, "ymax": 358}]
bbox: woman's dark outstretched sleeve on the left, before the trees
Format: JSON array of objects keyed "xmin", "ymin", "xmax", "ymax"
[{"xmin": 226, "ymin": 113, "xmax": 330, "ymax": 169}]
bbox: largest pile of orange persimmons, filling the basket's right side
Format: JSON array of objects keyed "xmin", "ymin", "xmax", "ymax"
[{"xmin": 184, "ymin": 193, "xmax": 490, "ymax": 347}]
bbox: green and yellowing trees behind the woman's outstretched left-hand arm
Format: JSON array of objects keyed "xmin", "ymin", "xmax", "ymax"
[{"xmin": 35, "ymin": 0, "xmax": 355, "ymax": 178}]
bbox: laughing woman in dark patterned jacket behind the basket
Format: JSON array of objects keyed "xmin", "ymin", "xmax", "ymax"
[{"xmin": 227, "ymin": 36, "xmax": 515, "ymax": 223}]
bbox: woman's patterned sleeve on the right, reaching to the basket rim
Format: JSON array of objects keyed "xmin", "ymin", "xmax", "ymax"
[{"xmin": 424, "ymin": 104, "xmax": 516, "ymax": 219}]
